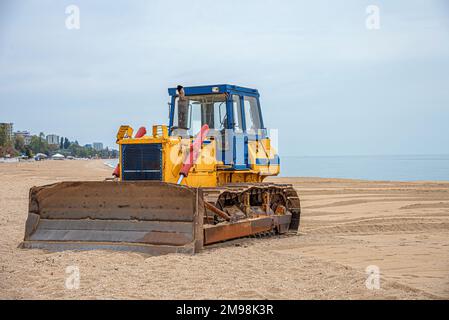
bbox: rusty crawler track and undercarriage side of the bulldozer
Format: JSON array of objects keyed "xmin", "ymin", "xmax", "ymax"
[{"xmin": 201, "ymin": 183, "xmax": 301, "ymax": 244}]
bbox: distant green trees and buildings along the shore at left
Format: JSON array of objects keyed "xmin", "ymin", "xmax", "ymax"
[{"xmin": 0, "ymin": 128, "xmax": 118, "ymax": 158}]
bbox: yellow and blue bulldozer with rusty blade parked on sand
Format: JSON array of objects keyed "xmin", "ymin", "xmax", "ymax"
[{"xmin": 20, "ymin": 84, "xmax": 301, "ymax": 255}]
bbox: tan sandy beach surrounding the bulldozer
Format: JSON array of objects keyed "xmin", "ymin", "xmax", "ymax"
[{"xmin": 0, "ymin": 160, "xmax": 449, "ymax": 299}]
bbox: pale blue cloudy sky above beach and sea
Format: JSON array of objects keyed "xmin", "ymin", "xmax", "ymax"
[{"xmin": 0, "ymin": 0, "xmax": 449, "ymax": 156}]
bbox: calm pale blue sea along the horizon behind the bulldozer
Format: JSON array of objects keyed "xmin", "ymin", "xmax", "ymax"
[{"xmin": 105, "ymin": 154, "xmax": 449, "ymax": 181}]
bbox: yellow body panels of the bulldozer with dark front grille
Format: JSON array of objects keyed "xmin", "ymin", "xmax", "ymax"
[{"xmin": 117, "ymin": 125, "xmax": 279, "ymax": 187}]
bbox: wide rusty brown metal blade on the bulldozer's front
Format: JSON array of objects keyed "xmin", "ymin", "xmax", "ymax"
[{"xmin": 21, "ymin": 181, "xmax": 204, "ymax": 255}]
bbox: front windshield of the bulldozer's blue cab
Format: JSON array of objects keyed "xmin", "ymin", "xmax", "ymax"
[{"xmin": 172, "ymin": 94, "xmax": 227, "ymax": 136}]
